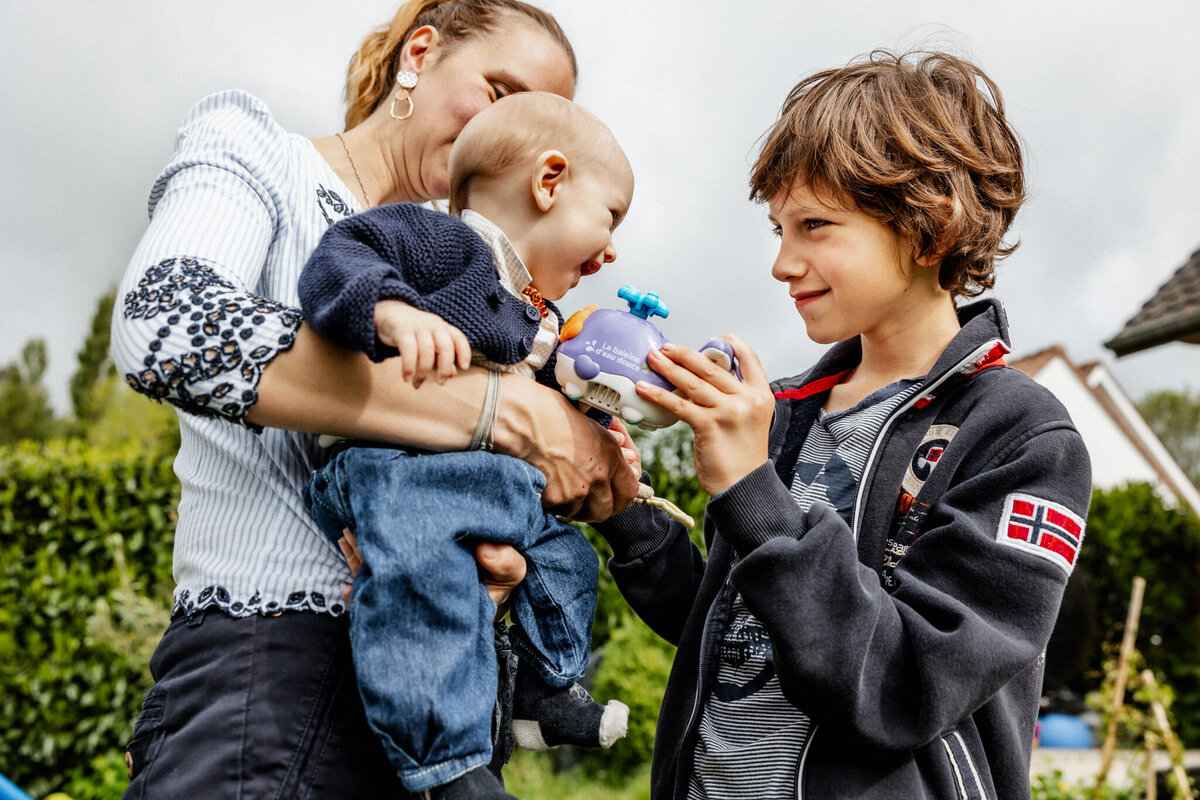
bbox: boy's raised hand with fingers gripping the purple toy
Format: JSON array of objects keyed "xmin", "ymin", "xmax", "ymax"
[{"xmin": 637, "ymin": 336, "xmax": 775, "ymax": 494}]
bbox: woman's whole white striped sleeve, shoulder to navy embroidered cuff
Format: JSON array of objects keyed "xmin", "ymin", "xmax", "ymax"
[{"xmin": 112, "ymin": 94, "xmax": 312, "ymax": 431}]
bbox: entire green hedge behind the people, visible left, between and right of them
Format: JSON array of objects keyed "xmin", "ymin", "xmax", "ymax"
[{"xmin": 11, "ymin": 427, "xmax": 1200, "ymax": 800}]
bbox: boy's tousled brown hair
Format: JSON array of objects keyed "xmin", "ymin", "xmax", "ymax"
[{"xmin": 750, "ymin": 50, "xmax": 1025, "ymax": 296}]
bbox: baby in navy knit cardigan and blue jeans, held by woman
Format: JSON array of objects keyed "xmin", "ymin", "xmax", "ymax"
[{"xmin": 300, "ymin": 92, "xmax": 634, "ymax": 798}]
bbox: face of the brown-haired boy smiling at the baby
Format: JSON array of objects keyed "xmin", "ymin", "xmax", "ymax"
[{"xmin": 769, "ymin": 186, "xmax": 949, "ymax": 344}]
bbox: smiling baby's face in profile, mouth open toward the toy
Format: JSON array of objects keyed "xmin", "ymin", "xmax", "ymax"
[{"xmin": 522, "ymin": 151, "xmax": 634, "ymax": 300}]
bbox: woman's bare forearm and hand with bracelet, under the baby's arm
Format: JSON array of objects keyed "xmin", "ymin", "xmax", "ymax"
[{"xmin": 246, "ymin": 326, "xmax": 637, "ymax": 521}]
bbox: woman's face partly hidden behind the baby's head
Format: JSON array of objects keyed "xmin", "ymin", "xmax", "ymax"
[{"xmin": 400, "ymin": 24, "xmax": 575, "ymax": 199}]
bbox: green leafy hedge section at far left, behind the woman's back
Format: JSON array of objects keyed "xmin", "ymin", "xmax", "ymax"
[{"xmin": 0, "ymin": 441, "xmax": 178, "ymax": 796}]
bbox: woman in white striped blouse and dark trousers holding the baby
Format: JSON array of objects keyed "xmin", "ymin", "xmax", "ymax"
[{"xmin": 113, "ymin": 0, "xmax": 636, "ymax": 798}]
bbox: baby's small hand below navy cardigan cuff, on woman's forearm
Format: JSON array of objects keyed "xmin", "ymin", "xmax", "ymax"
[{"xmin": 374, "ymin": 300, "xmax": 470, "ymax": 387}]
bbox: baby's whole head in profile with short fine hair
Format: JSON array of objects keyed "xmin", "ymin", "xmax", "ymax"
[{"xmin": 450, "ymin": 92, "xmax": 634, "ymax": 300}]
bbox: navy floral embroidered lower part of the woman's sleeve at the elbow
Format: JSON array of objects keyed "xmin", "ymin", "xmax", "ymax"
[{"xmin": 122, "ymin": 257, "xmax": 300, "ymax": 422}]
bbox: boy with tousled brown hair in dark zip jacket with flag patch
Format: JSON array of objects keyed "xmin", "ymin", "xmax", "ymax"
[{"xmin": 600, "ymin": 52, "xmax": 1091, "ymax": 800}]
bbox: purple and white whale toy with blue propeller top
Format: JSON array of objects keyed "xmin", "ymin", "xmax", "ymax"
[{"xmin": 554, "ymin": 285, "xmax": 737, "ymax": 431}]
